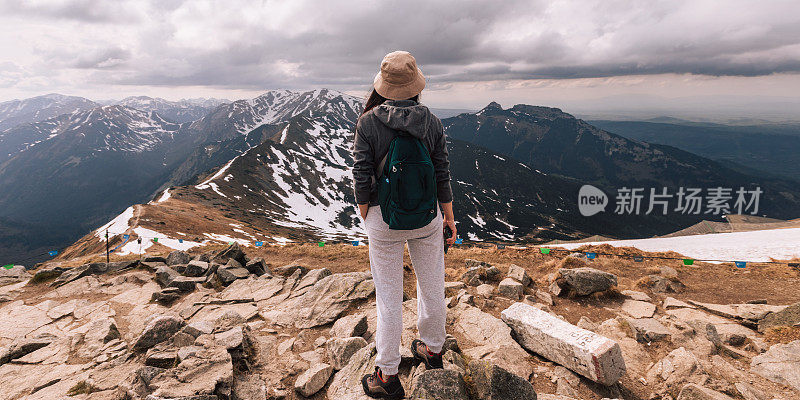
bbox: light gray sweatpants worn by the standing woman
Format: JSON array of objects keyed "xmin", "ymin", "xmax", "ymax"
[{"xmin": 364, "ymin": 206, "xmax": 447, "ymax": 375}]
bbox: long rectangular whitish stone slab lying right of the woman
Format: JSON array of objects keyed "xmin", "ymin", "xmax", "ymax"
[{"xmin": 501, "ymin": 303, "xmax": 625, "ymax": 385}]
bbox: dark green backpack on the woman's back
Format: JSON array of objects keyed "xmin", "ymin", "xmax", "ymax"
[{"xmin": 377, "ymin": 131, "xmax": 437, "ymax": 230}]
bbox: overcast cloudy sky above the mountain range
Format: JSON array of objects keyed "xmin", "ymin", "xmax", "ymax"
[{"xmin": 0, "ymin": 0, "xmax": 800, "ymax": 119}]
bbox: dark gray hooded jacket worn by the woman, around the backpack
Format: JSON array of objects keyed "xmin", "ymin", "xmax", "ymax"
[{"xmin": 353, "ymin": 100, "xmax": 453, "ymax": 206}]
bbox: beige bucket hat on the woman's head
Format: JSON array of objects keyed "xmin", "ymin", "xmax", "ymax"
[{"xmin": 373, "ymin": 51, "xmax": 425, "ymax": 100}]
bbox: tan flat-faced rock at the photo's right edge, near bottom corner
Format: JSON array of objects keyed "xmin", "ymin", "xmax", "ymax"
[{"xmin": 750, "ymin": 340, "xmax": 800, "ymax": 390}]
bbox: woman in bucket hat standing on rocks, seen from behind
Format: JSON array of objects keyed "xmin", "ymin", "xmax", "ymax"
[{"xmin": 353, "ymin": 51, "xmax": 456, "ymax": 399}]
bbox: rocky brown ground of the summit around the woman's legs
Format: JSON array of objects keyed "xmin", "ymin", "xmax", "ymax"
[{"xmin": 0, "ymin": 245, "xmax": 800, "ymax": 400}]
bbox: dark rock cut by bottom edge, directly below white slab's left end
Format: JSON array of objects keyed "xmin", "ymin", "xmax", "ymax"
[{"xmin": 469, "ymin": 360, "xmax": 536, "ymax": 400}]
